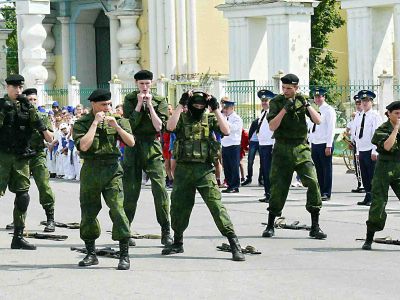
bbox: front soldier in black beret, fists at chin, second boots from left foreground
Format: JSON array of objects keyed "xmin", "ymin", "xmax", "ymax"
[{"xmin": 73, "ymin": 89, "xmax": 135, "ymax": 270}]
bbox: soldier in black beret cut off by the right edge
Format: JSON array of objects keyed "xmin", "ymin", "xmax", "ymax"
[{"xmin": 362, "ymin": 101, "xmax": 400, "ymax": 250}]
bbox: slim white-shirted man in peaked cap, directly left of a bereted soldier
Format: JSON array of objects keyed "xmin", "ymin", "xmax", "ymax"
[{"xmin": 256, "ymin": 90, "xmax": 276, "ymax": 203}]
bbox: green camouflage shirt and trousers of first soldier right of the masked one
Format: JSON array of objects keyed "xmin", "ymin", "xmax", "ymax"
[{"xmin": 267, "ymin": 94, "xmax": 322, "ymax": 216}]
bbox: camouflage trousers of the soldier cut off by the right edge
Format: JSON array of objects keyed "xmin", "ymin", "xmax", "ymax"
[{"xmin": 367, "ymin": 159, "xmax": 400, "ymax": 232}]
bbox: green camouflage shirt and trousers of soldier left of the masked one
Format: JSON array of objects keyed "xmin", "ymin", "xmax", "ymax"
[{"xmin": 123, "ymin": 92, "xmax": 169, "ymax": 227}]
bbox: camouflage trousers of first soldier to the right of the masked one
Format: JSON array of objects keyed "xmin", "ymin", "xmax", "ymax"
[{"xmin": 268, "ymin": 141, "xmax": 322, "ymax": 216}]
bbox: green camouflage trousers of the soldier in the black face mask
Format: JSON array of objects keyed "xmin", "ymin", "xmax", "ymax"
[{"xmin": 171, "ymin": 162, "xmax": 235, "ymax": 237}]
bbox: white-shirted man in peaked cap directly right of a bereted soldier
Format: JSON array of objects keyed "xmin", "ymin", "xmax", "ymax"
[{"xmin": 309, "ymin": 87, "xmax": 336, "ymax": 201}]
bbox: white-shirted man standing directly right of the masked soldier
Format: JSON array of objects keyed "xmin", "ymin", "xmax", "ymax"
[{"xmin": 221, "ymin": 101, "xmax": 243, "ymax": 193}]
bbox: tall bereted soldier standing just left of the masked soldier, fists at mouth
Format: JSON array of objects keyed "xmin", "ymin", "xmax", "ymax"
[{"xmin": 123, "ymin": 70, "xmax": 172, "ymax": 245}]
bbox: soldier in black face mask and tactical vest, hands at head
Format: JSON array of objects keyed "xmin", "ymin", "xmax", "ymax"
[{"xmin": 162, "ymin": 91, "xmax": 245, "ymax": 261}]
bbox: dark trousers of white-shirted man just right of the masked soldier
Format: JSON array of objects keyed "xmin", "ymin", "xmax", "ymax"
[{"xmin": 222, "ymin": 145, "xmax": 240, "ymax": 189}]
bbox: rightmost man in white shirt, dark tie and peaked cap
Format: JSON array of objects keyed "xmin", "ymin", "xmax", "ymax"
[{"xmin": 354, "ymin": 90, "xmax": 382, "ymax": 206}]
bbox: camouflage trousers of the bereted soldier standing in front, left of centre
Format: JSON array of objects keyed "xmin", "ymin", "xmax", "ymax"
[{"xmin": 80, "ymin": 159, "xmax": 131, "ymax": 241}]
